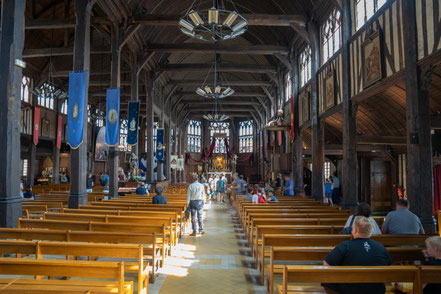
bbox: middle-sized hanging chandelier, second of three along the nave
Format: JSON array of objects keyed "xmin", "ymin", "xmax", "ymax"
[{"xmin": 196, "ymin": 51, "xmax": 234, "ymax": 99}]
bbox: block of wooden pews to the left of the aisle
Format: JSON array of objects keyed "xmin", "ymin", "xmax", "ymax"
[{"xmin": 0, "ymin": 185, "xmax": 187, "ymax": 293}]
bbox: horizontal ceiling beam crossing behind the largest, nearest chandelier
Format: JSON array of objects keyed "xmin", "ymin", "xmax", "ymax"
[{"xmin": 129, "ymin": 14, "xmax": 308, "ymax": 27}]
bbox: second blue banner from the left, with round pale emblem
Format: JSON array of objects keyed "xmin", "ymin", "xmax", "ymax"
[{"xmin": 106, "ymin": 89, "xmax": 120, "ymax": 147}]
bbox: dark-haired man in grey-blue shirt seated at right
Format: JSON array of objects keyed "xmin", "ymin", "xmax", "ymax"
[{"xmin": 381, "ymin": 199, "xmax": 424, "ymax": 235}]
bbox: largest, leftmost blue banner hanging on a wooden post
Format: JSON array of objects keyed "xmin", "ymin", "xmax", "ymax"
[{"xmin": 67, "ymin": 71, "xmax": 87, "ymax": 149}]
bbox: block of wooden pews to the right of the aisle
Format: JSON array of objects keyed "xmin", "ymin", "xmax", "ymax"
[{"xmin": 236, "ymin": 196, "xmax": 441, "ymax": 294}]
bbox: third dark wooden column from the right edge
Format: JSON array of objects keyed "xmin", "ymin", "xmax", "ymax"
[{"xmin": 308, "ymin": 21, "xmax": 325, "ymax": 201}]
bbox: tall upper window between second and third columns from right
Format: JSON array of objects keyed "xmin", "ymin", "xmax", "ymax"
[{"xmin": 322, "ymin": 9, "xmax": 341, "ymax": 63}]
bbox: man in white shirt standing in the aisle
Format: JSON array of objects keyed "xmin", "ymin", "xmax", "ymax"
[{"xmin": 187, "ymin": 174, "xmax": 205, "ymax": 236}]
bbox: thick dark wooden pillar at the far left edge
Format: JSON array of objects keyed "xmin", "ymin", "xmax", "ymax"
[{"xmin": 0, "ymin": 0, "xmax": 26, "ymax": 227}]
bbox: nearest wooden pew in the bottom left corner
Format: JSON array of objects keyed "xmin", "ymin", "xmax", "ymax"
[{"xmin": 0, "ymin": 258, "xmax": 133, "ymax": 293}]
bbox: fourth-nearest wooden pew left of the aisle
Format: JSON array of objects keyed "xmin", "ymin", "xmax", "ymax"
[{"xmin": 18, "ymin": 218, "xmax": 170, "ymax": 263}]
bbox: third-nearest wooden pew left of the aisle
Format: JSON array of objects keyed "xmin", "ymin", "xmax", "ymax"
[{"xmin": 0, "ymin": 228, "xmax": 162, "ymax": 282}]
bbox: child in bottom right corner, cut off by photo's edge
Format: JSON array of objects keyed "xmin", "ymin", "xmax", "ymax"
[{"xmin": 395, "ymin": 236, "xmax": 441, "ymax": 294}]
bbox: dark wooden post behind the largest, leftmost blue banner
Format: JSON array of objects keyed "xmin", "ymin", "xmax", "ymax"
[{"xmin": 69, "ymin": 0, "xmax": 95, "ymax": 208}]
